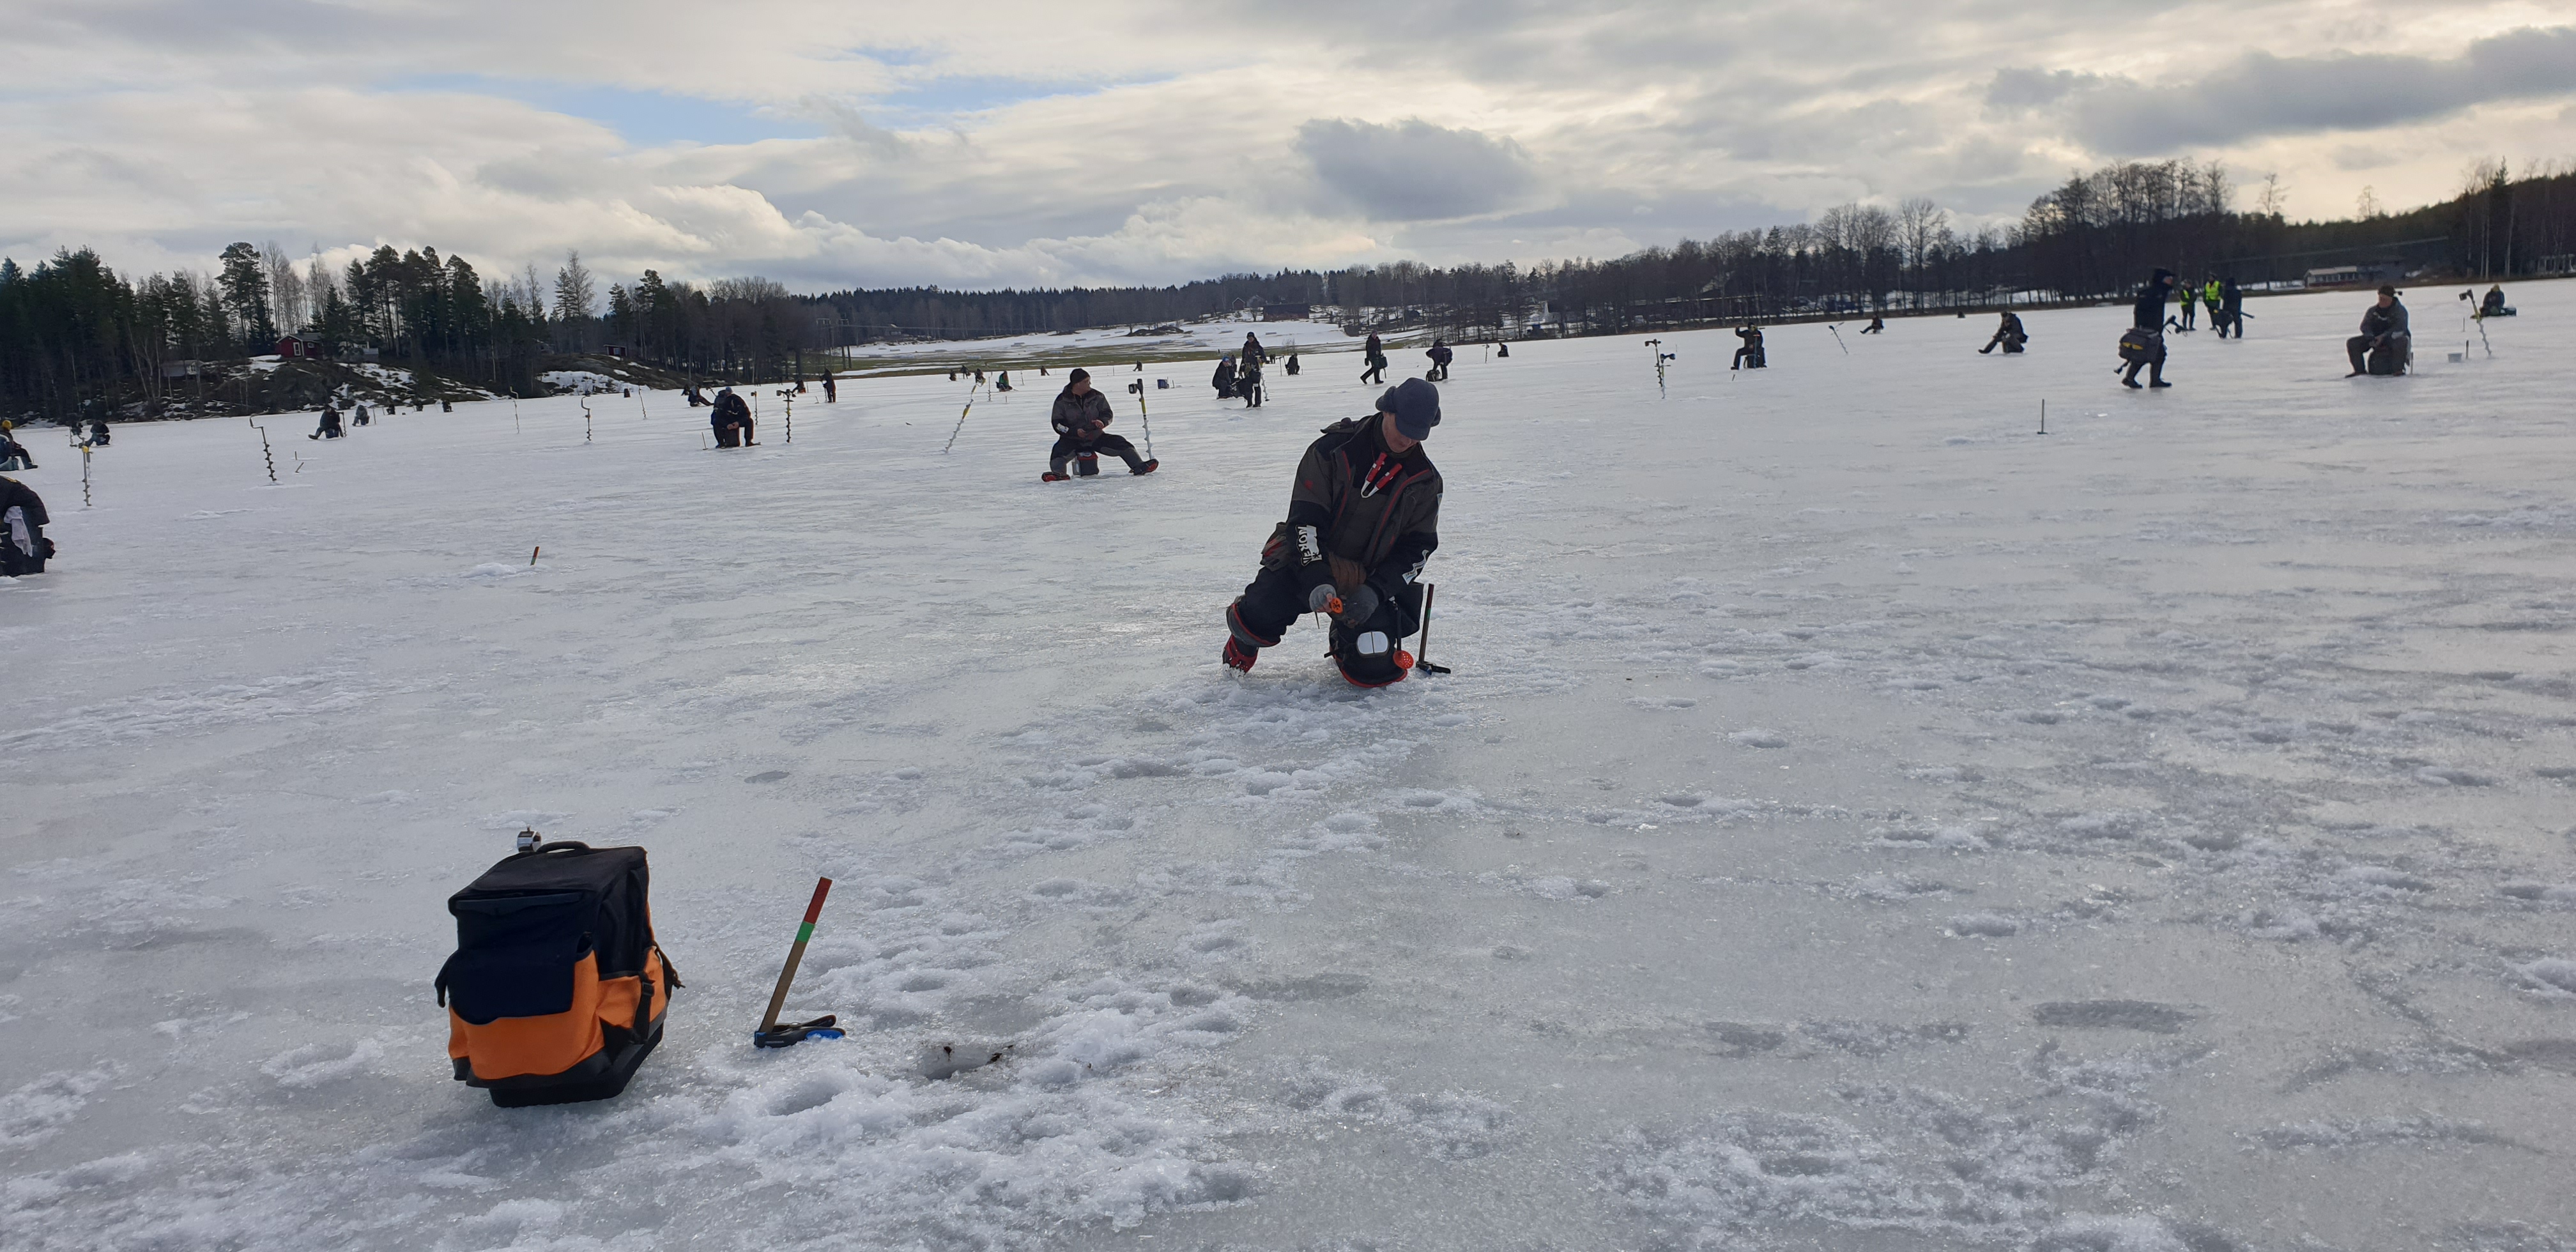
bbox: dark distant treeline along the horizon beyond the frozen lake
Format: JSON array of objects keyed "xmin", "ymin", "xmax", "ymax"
[{"xmin": 0, "ymin": 160, "xmax": 2576, "ymax": 417}]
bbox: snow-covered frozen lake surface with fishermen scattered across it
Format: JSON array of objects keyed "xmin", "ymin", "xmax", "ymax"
[{"xmin": 0, "ymin": 284, "xmax": 2576, "ymax": 1252}]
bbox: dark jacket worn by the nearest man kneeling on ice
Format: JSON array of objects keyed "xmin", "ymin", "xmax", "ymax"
[{"xmin": 1285, "ymin": 415, "xmax": 1440, "ymax": 600}]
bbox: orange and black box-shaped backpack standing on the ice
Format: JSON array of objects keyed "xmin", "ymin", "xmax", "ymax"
[{"xmin": 438, "ymin": 835, "xmax": 680, "ymax": 1108}]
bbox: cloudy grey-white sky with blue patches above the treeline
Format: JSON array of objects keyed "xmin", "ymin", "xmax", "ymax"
[{"xmin": 15, "ymin": 0, "xmax": 2576, "ymax": 291}]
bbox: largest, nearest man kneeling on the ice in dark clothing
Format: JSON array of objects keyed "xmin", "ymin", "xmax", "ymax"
[{"xmin": 1223, "ymin": 379, "xmax": 1440, "ymax": 688}]
